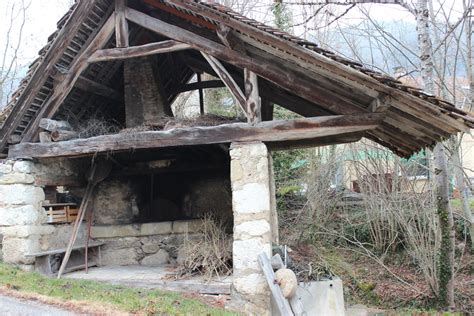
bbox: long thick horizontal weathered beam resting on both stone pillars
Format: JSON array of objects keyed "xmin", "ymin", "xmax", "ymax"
[{"xmin": 9, "ymin": 113, "xmax": 384, "ymax": 158}]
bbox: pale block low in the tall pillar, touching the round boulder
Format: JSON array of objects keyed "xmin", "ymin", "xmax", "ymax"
[{"xmin": 233, "ymin": 239, "xmax": 272, "ymax": 275}]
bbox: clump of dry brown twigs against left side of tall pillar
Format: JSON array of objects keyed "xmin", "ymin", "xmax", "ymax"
[{"xmin": 177, "ymin": 215, "xmax": 232, "ymax": 280}]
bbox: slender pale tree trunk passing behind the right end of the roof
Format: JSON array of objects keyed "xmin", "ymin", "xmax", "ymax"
[{"xmin": 416, "ymin": 0, "xmax": 454, "ymax": 309}]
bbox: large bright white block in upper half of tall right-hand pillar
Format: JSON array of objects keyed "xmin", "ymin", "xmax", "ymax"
[{"xmin": 232, "ymin": 183, "xmax": 270, "ymax": 213}]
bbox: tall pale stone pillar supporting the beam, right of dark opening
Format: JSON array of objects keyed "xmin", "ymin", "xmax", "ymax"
[{"xmin": 230, "ymin": 142, "xmax": 276, "ymax": 315}]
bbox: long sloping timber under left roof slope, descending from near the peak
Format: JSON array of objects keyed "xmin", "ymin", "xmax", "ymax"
[{"xmin": 23, "ymin": 16, "xmax": 115, "ymax": 142}]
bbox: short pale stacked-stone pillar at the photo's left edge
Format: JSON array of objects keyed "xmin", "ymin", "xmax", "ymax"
[{"xmin": 0, "ymin": 160, "xmax": 48, "ymax": 265}]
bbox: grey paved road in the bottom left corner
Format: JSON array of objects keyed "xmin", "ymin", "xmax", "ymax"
[{"xmin": 0, "ymin": 295, "xmax": 75, "ymax": 316}]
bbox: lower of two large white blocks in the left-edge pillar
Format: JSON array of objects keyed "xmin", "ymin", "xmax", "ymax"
[{"xmin": 0, "ymin": 205, "xmax": 46, "ymax": 226}]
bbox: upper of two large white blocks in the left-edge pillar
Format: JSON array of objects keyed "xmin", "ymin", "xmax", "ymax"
[{"xmin": 0, "ymin": 184, "xmax": 44, "ymax": 206}]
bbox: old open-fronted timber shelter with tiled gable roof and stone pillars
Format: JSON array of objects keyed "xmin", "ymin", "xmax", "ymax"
[{"xmin": 0, "ymin": 0, "xmax": 474, "ymax": 313}]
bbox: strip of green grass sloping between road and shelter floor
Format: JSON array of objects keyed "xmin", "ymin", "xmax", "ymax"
[{"xmin": 0, "ymin": 263, "xmax": 235, "ymax": 315}]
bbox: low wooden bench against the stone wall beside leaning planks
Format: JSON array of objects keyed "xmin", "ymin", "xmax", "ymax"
[{"xmin": 26, "ymin": 243, "xmax": 104, "ymax": 276}]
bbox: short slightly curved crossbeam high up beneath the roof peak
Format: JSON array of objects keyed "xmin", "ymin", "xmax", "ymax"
[{"xmin": 88, "ymin": 40, "xmax": 190, "ymax": 63}]
